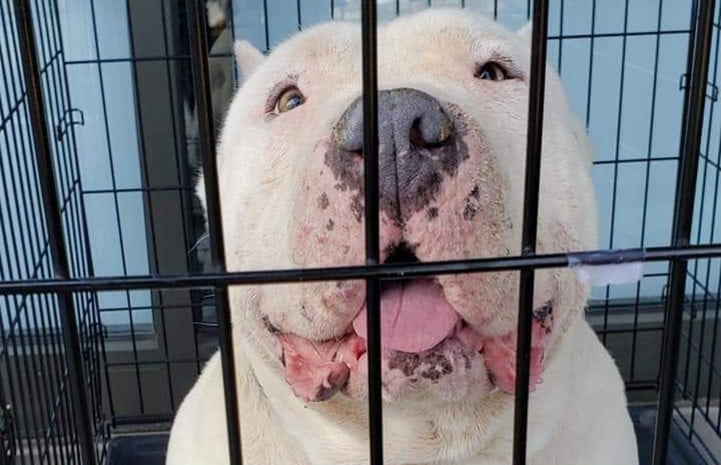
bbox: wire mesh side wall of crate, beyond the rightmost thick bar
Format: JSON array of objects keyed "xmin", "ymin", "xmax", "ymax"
[{"xmin": 676, "ymin": 5, "xmax": 721, "ymax": 463}]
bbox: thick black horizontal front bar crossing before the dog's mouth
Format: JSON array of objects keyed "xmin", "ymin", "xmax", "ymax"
[{"xmin": 0, "ymin": 244, "xmax": 721, "ymax": 295}]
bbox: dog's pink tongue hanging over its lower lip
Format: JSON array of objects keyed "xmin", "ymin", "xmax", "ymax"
[{"xmin": 353, "ymin": 279, "xmax": 458, "ymax": 353}]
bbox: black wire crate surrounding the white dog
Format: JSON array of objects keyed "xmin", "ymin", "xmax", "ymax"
[{"xmin": 0, "ymin": 0, "xmax": 721, "ymax": 465}]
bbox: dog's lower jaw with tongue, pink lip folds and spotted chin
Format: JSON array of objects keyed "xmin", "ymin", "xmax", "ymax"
[{"xmin": 265, "ymin": 279, "xmax": 552, "ymax": 402}]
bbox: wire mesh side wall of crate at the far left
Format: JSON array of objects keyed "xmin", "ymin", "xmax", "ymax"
[{"xmin": 0, "ymin": 1, "xmax": 106, "ymax": 464}]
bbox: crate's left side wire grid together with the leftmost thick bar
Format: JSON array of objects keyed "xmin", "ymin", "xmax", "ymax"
[{"xmin": 0, "ymin": 2, "xmax": 106, "ymax": 464}]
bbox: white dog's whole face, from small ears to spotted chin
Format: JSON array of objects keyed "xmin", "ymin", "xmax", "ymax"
[{"xmin": 199, "ymin": 10, "xmax": 596, "ymax": 402}]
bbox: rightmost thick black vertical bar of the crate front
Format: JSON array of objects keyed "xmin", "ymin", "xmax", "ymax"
[{"xmin": 653, "ymin": 0, "xmax": 716, "ymax": 465}]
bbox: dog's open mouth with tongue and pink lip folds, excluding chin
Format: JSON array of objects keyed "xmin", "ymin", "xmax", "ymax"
[{"xmin": 266, "ymin": 242, "xmax": 553, "ymax": 401}]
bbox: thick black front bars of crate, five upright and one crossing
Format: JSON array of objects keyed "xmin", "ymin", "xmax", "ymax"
[{"xmin": 0, "ymin": 0, "xmax": 721, "ymax": 465}]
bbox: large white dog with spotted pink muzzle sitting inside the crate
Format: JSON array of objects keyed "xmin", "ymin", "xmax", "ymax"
[{"xmin": 167, "ymin": 9, "xmax": 638, "ymax": 465}]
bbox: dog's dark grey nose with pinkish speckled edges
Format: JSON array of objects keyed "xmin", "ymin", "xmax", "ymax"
[{"xmin": 334, "ymin": 88, "xmax": 458, "ymax": 220}]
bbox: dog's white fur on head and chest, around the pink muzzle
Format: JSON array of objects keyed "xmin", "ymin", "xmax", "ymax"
[{"xmin": 167, "ymin": 10, "xmax": 638, "ymax": 465}]
